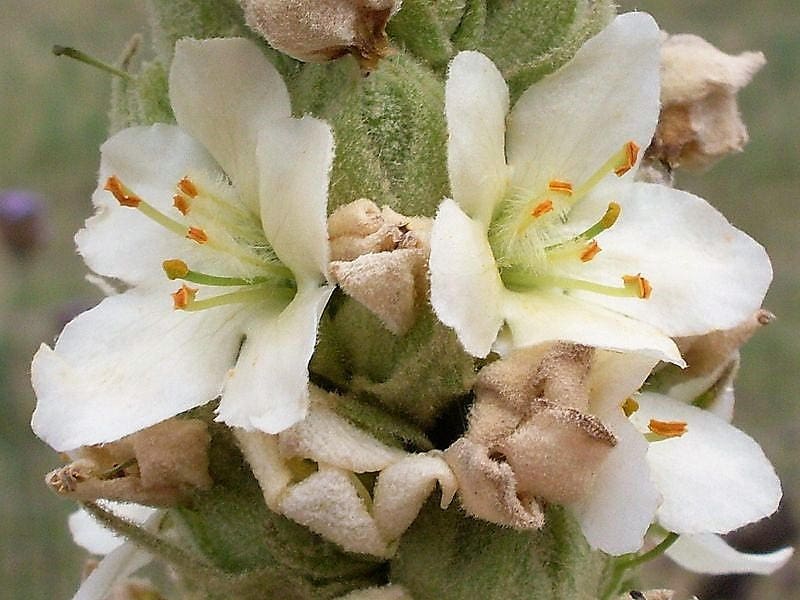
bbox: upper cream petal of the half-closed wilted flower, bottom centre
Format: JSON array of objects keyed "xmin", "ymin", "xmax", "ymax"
[{"xmin": 279, "ymin": 394, "xmax": 407, "ymax": 473}]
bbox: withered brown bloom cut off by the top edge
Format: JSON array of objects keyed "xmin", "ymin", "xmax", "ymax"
[{"xmin": 241, "ymin": 0, "xmax": 400, "ymax": 70}]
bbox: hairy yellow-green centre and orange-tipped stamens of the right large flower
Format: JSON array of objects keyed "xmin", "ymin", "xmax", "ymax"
[{"xmin": 489, "ymin": 141, "xmax": 652, "ymax": 299}]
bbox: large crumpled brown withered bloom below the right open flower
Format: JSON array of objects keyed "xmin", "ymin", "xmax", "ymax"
[{"xmin": 446, "ymin": 343, "xmax": 616, "ymax": 529}]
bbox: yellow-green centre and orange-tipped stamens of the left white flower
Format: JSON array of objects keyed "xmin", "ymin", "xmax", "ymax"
[{"xmin": 104, "ymin": 175, "xmax": 297, "ymax": 311}]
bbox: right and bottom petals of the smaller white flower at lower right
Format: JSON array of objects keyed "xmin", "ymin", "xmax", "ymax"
[{"xmin": 631, "ymin": 393, "xmax": 793, "ymax": 574}]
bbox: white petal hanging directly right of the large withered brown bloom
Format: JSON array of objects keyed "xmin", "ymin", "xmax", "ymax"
[{"xmin": 572, "ymin": 408, "xmax": 660, "ymax": 555}]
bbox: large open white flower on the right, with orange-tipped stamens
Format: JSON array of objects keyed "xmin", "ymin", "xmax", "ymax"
[{"xmin": 430, "ymin": 13, "xmax": 771, "ymax": 364}]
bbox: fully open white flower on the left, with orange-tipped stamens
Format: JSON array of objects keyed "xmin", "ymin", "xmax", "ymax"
[{"xmin": 32, "ymin": 39, "xmax": 333, "ymax": 450}]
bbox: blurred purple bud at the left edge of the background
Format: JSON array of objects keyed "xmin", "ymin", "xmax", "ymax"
[{"xmin": 0, "ymin": 190, "xmax": 44, "ymax": 258}]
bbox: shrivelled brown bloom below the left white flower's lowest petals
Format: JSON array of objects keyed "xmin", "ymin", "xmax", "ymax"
[{"xmin": 45, "ymin": 419, "xmax": 212, "ymax": 506}]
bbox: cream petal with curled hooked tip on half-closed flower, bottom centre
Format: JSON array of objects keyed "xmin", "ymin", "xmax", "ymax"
[{"xmin": 372, "ymin": 452, "xmax": 458, "ymax": 541}]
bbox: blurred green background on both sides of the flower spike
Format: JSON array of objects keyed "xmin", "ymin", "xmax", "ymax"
[{"xmin": 0, "ymin": 0, "xmax": 800, "ymax": 600}]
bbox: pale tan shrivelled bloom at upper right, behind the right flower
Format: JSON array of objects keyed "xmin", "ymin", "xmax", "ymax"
[{"xmin": 646, "ymin": 34, "xmax": 766, "ymax": 169}]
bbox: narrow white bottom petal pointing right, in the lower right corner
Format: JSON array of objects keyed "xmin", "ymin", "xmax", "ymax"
[{"xmin": 667, "ymin": 533, "xmax": 794, "ymax": 575}]
